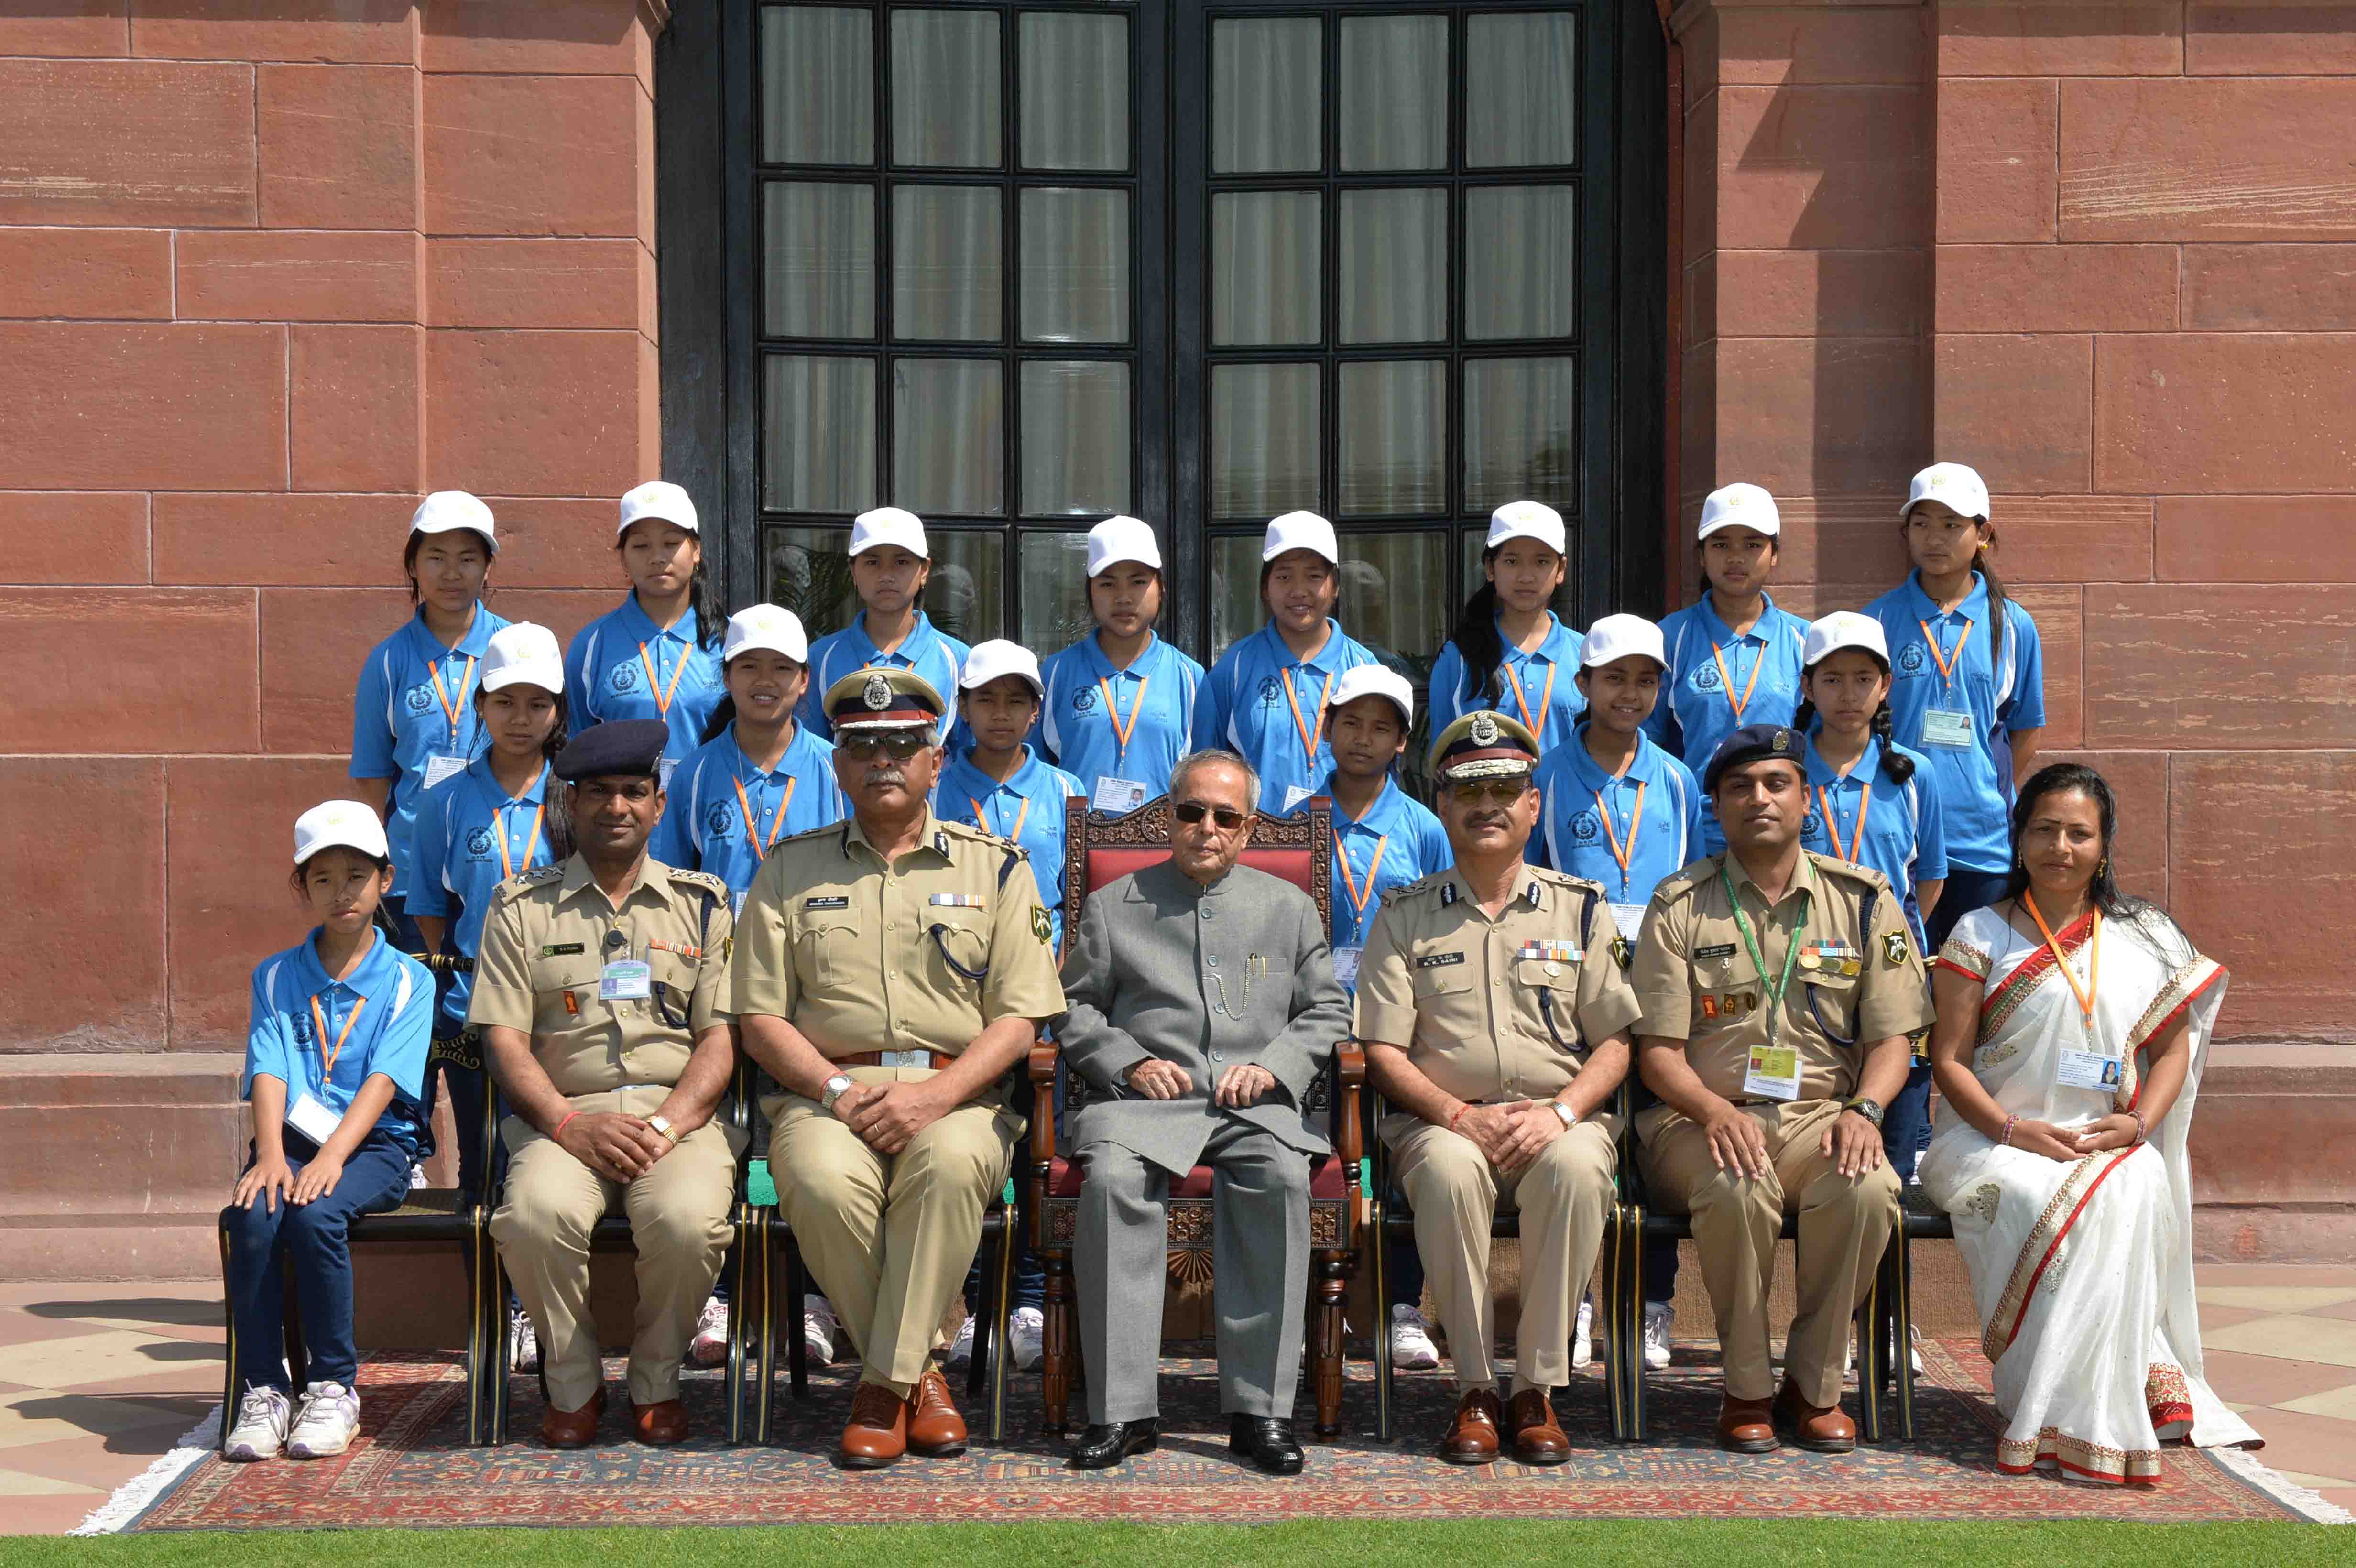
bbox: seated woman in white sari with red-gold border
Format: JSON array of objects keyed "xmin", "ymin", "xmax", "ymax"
[{"xmin": 1922, "ymin": 765, "xmax": 2259, "ymax": 1486}]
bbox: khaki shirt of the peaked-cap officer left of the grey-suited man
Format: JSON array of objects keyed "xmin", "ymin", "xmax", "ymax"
[{"xmin": 735, "ymin": 810, "xmax": 1063, "ymax": 1059}]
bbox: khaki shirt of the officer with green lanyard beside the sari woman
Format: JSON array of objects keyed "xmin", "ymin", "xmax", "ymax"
[{"xmin": 1633, "ymin": 850, "xmax": 1932, "ymax": 1100}]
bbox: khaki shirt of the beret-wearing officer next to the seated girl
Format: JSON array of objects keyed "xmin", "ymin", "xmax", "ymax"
[{"xmin": 467, "ymin": 855, "xmax": 735, "ymax": 1095}]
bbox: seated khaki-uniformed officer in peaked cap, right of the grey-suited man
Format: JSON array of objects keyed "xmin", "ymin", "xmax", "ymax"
[{"xmin": 1357, "ymin": 713, "xmax": 1640, "ymax": 1464}]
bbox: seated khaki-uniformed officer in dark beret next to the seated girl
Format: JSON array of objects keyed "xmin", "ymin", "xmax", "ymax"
[{"xmin": 467, "ymin": 720, "xmax": 744, "ymax": 1448}]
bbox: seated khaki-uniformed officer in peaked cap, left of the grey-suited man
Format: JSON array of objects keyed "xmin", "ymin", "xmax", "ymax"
[{"xmin": 735, "ymin": 669, "xmax": 1063, "ymax": 1469}]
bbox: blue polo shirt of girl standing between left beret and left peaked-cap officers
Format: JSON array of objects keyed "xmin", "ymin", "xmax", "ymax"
[{"xmin": 645, "ymin": 723, "xmax": 846, "ymax": 906}]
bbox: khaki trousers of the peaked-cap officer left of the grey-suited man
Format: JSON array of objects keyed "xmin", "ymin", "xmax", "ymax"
[{"xmin": 761, "ymin": 1067, "xmax": 1023, "ymax": 1398}]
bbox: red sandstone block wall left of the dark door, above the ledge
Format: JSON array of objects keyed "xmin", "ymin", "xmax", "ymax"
[{"xmin": 0, "ymin": 0, "xmax": 660, "ymax": 1052}]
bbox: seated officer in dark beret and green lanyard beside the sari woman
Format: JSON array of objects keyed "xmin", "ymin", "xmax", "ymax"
[{"xmin": 1635, "ymin": 725, "xmax": 1930, "ymax": 1453}]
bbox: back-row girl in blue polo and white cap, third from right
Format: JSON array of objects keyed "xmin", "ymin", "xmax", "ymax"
[{"xmin": 1428, "ymin": 501, "xmax": 1583, "ymax": 756}]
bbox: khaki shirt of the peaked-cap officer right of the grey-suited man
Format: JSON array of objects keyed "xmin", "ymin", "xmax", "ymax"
[{"xmin": 1357, "ymin": 866, "xmax": 1642, "ymax": 1100}]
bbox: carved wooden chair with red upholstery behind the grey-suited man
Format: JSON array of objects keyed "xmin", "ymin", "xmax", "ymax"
[{"xmin": 1030, "ymin": 796, "xmax": 1366, "ymax": 1436}]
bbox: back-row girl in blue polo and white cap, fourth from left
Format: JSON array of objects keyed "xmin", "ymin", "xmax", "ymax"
[{"xmin": 1032, "ymin": 518, "xmax": 1201, "ymax": 812}]
